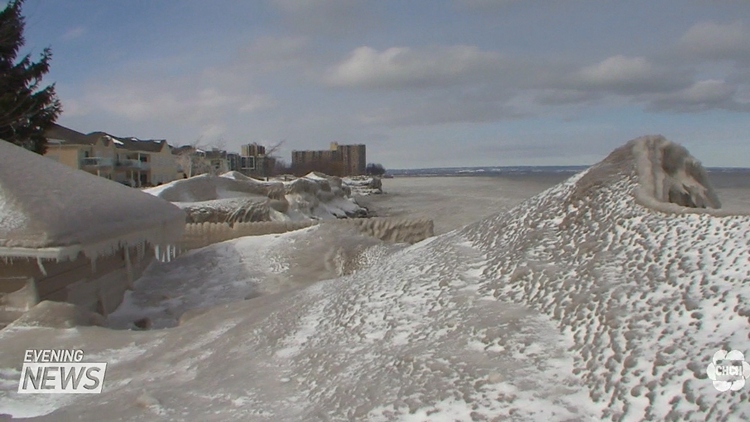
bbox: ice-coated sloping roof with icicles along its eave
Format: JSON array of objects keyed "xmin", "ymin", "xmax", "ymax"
[{"xmin": 0, "ymin": 141, "xmax": 185, "ymax": 260}]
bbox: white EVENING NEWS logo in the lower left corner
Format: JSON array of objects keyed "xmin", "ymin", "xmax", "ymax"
[{"xmin": 18, "ymin": 349, "xmax": 107, "ymax": 394}]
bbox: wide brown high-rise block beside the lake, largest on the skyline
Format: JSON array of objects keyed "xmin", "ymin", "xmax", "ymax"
[{"xmin": 292, "ymin": 142, "xmax": 367, "ymax": 176}]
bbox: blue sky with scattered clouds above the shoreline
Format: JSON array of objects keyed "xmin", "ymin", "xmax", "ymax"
[{"xmin": 14, "ymin": 0, "xmax": 750, "ymax": 169}]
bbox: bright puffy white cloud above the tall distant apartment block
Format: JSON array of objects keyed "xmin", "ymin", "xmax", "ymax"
[{"xmin": 327, "ymin": 45, "xmax": 502, "ymax": 90}]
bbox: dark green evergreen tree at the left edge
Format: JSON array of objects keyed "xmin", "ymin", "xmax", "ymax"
[{"xmin": 0, "ymin": 0, "xmax": 62, "ymax": 154}]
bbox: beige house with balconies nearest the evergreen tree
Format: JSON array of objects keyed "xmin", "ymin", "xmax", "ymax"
[{"xmin": 45, "ymin": 125, "xmax": 178, "ymax": 187}]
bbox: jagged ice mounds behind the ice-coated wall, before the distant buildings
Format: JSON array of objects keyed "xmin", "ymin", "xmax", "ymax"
[{"xmin": 145, "ymin": 172, "xmax": 368, "ymax": 224}]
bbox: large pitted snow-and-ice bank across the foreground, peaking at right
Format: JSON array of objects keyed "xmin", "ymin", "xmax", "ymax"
[{"xmin": 0, "ymin": 137, "xmax": 750, "ymax": 421}]
